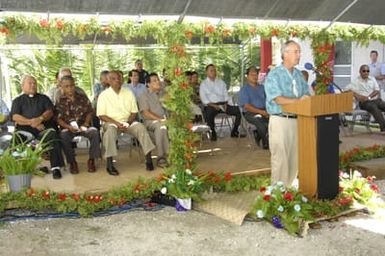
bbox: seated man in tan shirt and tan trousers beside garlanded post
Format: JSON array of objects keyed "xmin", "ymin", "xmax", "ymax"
[{"xmin": 139, "ymin": 73, "xmax": 169, "ymax": 168}]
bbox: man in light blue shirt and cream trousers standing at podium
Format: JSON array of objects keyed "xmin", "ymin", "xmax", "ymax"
[{"xmin": 265, "ymin": 40, "xmax": 310, "ymax": 187}]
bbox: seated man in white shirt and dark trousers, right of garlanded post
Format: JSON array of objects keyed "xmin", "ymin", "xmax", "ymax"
[{"xmin": 199, "ymin": 64, "xmax": 241, "ymax": 141}]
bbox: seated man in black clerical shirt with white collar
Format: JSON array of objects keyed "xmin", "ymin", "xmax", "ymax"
[{"xmin": 11, "ymin": 75, "xmax": 64, "ymax": 179}]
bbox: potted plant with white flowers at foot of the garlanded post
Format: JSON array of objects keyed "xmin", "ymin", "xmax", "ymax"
[{"xmin": 160, "ymin": 169, "xmax": 204, "ymax": 211}]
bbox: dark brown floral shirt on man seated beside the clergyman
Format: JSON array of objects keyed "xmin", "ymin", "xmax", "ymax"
[{"xmin": 55, "ymin": 92, "xmax": 93, "ymax": 126}]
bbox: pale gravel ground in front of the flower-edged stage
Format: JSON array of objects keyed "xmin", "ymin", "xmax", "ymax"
[{"xmin": 0, "ymin": 180, "xmax": 385, "ymax": 256}]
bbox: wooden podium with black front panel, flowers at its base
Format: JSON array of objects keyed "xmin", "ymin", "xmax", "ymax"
[{"xmin": 282, "ymin": 92, "xmax": 353, "ymax": 199}]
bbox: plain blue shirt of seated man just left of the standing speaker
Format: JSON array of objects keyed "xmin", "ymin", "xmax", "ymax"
[{"xmin": 239, "ymin": 84, "xmax": 266, "ymax": 111}]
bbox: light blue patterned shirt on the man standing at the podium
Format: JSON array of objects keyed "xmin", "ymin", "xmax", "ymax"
[{"xmin": 265, "ymin": 64, "xmax": 310, "ymax": 115}]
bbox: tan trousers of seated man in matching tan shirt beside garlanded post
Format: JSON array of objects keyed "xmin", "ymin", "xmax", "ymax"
[{"xmin": 144, "ymin": 120, "xmax": 169, "ymax": 159}]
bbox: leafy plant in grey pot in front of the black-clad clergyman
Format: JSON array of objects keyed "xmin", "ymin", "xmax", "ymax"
[{"xmin": 0, "ymin": 132, "xmax": 50, "ymax": 192}]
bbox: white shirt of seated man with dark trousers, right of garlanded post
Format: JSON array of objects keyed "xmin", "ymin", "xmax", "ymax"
[{"xmin": 199, "ymin": 78, "xmax": 229, "ymax": 105}]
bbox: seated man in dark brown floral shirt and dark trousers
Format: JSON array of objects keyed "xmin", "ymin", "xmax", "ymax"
[{"xmin": 55, "ymin": 76, "xmax": 101, "ymax": 174}]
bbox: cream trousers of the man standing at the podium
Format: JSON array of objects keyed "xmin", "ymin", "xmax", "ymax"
[{"xmin": 269, "ymin": 115, "xmax": 298, "ymax": 187}]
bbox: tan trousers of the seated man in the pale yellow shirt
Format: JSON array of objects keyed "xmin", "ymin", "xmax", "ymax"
[{"xmin": 103, "ymin": 122, "xmax": 155, "ymax": 158}]
